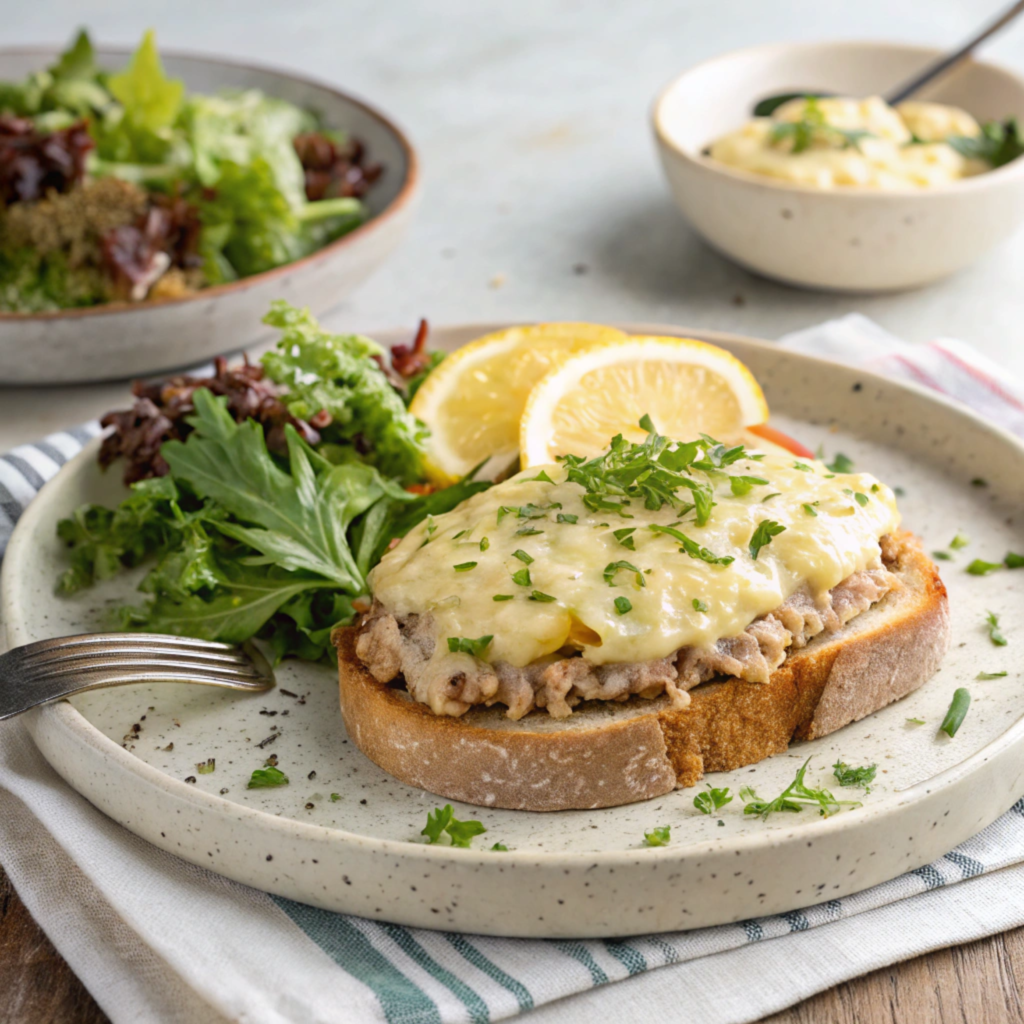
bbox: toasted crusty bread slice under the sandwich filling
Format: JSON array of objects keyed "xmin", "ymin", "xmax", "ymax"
[{"xmin": 335, "ymin": 532, "xmax": 949, "ymax": 811}]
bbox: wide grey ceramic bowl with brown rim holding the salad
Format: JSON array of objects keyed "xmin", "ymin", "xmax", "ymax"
[{"xmin": 0, "ymin": 48, "xmax": 418, "ymax": 384}]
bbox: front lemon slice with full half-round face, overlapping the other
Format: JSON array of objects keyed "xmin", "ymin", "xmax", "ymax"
[{"xmin": 519, "ymin": 337, "xmax": 768, "ymax": 469}]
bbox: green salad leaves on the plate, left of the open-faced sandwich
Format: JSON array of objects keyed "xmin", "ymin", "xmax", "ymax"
[{"xmin": 57, "ymin": 302, "xmax": 487, "ymax": 660}]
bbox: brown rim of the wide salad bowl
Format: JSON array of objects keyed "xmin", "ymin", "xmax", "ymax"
[{"xmin": 0, "ymin": 44, "xmax": 420, "ymax": 324}]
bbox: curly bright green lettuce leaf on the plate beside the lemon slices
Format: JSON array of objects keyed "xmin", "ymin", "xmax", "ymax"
[{"xmin": 262, "ymin": 301, "xmax": 427, "ymax": 483}]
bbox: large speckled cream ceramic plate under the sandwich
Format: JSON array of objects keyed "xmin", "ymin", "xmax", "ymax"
[{"xmin": 2, "ymin": 325, "xmax": 1024, "ymax": 936}]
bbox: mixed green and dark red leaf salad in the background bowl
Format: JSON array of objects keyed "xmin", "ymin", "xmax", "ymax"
[{"xmin": 0, "ymin": 32, "xmax": 382, "ymax": 312}]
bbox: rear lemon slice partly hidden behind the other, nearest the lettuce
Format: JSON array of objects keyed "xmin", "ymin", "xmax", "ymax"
[{"xmin": 410, "ymin": 324, "xmax": 626, "ymax": 483}]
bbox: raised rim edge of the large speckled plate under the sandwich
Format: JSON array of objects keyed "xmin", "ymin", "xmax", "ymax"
[{"xmin": 0, "ymin": 321, "xmax": 1024, "ymax": 867}]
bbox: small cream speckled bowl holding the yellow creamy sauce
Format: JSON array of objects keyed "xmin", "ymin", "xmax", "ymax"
[{"xmin": 652, "ymin": 42, "xmax": 1024, "ymax": 292}]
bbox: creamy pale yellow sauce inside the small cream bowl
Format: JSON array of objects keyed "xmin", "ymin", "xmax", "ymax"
[{"xmin": 710, "ymin": 96, "xmax": 990, "ymax": 189}]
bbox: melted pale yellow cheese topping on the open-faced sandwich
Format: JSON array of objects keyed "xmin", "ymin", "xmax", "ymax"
[{"xmin": 370, "ymin": 455, "xmax": 899, "ymax": 667}]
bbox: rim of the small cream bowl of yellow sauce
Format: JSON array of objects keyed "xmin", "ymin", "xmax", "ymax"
[{"xmin": 650, "ymin": 39, "xmax": 1024, "ymax": 203}]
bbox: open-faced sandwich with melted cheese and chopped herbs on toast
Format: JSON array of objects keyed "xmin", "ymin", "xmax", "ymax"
[{"xmin": 336, "ymin": 420, "xmax": 949, "ymax": 811}]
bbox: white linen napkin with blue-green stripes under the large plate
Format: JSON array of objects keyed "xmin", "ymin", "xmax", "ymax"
[{"xmin": 0, "ymin": 315, "xmax": 1024, "ymax": 1024}]
